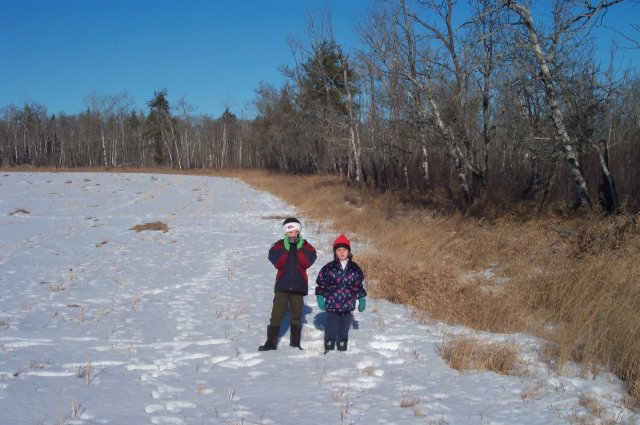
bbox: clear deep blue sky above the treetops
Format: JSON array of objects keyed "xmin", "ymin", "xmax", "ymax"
[{"xmin": 0, "ymin": 0, "xmax": 640, "ymax": 117}]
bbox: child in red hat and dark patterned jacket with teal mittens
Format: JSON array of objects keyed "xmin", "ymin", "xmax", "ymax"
[{"xmin": 316, "ymin": 235, "xmax": 367, "ymax": 354}]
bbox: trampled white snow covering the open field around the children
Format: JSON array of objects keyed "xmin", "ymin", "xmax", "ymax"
[{"xmin": 0, "ymin": 172, "xmax": 638, "ymax": 425}]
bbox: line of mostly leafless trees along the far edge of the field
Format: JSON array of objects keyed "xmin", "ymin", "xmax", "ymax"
[{"xmin": 0, "ymin": 0, "xmax": 640, "ymax": 212}]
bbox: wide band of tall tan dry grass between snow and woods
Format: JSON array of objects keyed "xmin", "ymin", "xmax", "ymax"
[{"xmin": 241, "ymin": 172, "xmax": 640, "ymax": 399}]
